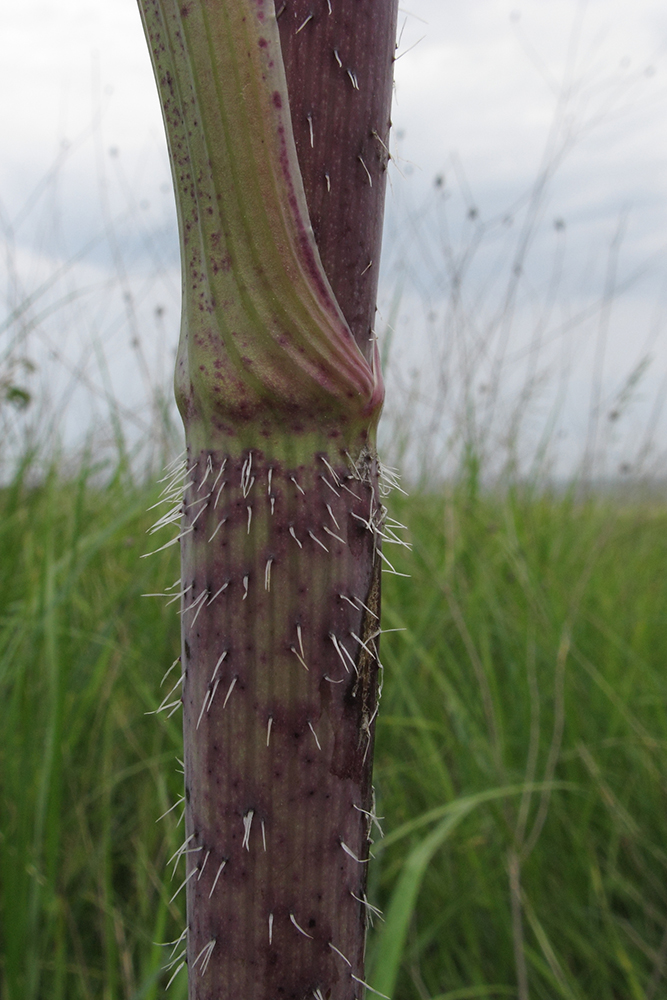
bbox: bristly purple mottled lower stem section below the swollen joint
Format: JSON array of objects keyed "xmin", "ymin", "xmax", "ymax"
[{"xmin": 183, "ymin": 451, "xmax": 379, "ymax": 1000}]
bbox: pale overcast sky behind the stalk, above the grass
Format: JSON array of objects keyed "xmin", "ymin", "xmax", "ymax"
[{"xmin": 0, "ymin": 0, "xmax": 667, "ymax": 476}]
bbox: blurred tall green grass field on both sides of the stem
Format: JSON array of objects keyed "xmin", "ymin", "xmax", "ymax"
[{"xmin": 0, "ymin": 461, "xmax": 667, "ymax": 1000}]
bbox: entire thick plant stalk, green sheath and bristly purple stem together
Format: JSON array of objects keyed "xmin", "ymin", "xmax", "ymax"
[{"xmin": 140, "ymin": 0, "xmax": 396, "ymax": 1000}]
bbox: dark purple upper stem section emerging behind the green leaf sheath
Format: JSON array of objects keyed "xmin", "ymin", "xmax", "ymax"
[{"xmin": 278, "ymin": 0, "xmax": 398, "ymax": 358}]
